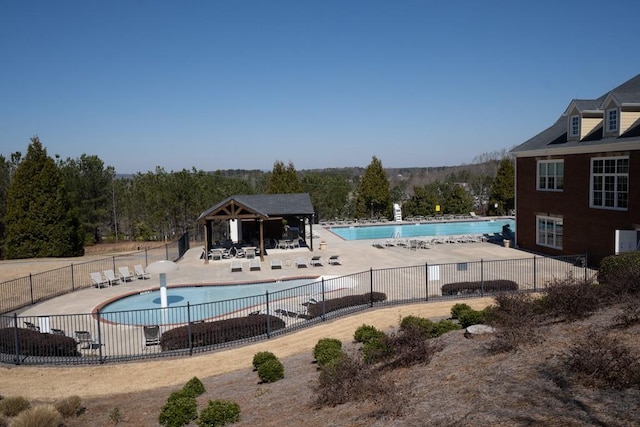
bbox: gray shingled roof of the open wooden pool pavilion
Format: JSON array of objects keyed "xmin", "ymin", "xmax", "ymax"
[{"xmin": 198, "ymin": 193, "xmax": 314, "ymax": 221}]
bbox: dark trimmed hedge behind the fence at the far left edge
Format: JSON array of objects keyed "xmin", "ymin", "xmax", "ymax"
[{"xmin": 0, "ymin": 328, "xmax": 82, "ymax": 357}]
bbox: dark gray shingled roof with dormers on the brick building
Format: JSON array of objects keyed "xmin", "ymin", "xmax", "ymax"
[{"xmin": 511, "ymin": 74, "xmax": 640, "ymax": 154}]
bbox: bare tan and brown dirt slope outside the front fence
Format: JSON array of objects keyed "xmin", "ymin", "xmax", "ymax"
[{"xmin": 0, "ymin": 249, "xmax": 640, "ymax": 427}]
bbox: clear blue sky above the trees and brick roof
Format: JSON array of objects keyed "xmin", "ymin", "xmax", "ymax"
[{"xmin": 0, "ymin": 0, "xmax": 640, "ymax": 173}]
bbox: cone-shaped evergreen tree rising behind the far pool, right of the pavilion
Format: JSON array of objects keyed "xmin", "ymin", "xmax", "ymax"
[{"xmin": 356, "ymin": 156, "xmax": 393, "ymax": 218}]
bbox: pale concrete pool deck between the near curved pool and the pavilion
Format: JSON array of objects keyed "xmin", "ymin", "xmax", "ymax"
[{"xmin": 21, "ymin": 223, "xmax": 532, "ymax": 316}]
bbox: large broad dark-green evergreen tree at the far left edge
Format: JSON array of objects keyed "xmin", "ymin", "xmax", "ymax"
[{"xmin": 4, "ymin": 137, "xmax": 84, "ymax": 258}]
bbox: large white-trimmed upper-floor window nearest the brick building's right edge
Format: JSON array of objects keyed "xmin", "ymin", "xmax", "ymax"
[{"xmin": 590, "ymin": 157, "xmax": 629, "ymax": 210}]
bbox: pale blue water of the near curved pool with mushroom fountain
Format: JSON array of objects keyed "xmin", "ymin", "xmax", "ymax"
[{"xmin": 100, "ymin": 279, "xmax": 318, "ymax": 325}]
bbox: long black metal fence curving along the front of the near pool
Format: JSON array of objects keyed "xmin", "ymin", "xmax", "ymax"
[{"xmin": 0, "ymin": 254, "xmax": 596, "ymax": 365}]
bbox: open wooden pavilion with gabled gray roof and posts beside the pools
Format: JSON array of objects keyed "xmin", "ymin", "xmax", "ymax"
[{"xmin": 198, "ymin": 193, "xmax": 314, "ymax": 263}]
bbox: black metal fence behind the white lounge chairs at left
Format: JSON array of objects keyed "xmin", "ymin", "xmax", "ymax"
[{"xmin": 0, "ymin": 233, "xmax": 189, "ymax": 313}]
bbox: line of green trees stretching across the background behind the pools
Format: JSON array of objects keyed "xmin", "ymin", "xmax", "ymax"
[{"xmin": 0, "ymin": 136, "xmax": 514, "ymax": 259}]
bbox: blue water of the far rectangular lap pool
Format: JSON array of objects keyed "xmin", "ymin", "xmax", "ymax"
[{"xmin": 331, "ymin": 218, "xmax": 516, "ymax": 240}]
